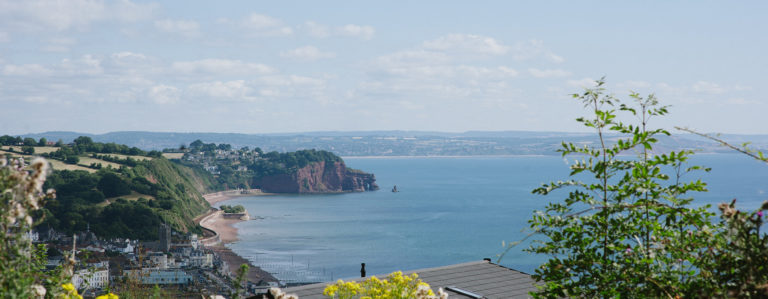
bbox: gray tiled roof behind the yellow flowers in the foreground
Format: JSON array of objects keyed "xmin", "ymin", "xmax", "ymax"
[{"xmin": 285, "ymin": 261, "xmax": 536, "ymax": 299}]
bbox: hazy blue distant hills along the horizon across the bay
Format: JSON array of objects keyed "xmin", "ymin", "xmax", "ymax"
[{"xmin": 16, "ymin": 131, "xmax": 768, "ymax": 156}]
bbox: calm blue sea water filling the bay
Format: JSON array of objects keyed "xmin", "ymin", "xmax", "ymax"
[{"xmin": 220, "ymin": 154, "xmax": 768, "ymax": 282}]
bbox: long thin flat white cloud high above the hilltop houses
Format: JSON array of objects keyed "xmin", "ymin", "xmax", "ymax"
[{"xmin": 172, "ymin": 58, "xmax": 275, "ymax": 75}]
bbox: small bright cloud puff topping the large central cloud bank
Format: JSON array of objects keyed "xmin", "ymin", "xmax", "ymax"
[{"xmin": 421, "ymin": 34, "xmax": 509, "ymax": 55}]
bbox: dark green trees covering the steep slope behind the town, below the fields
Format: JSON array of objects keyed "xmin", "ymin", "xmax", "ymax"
[{"xmin": 38, "ymin": 158, "xmax": 208, "ymax": 240}]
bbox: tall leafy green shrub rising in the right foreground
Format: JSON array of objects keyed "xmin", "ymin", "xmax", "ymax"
[{"xmin": 527, "ymin": 80, "xmax": 717, "ymax": 298}]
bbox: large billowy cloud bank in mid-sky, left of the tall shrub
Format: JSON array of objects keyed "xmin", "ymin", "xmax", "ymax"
[{"xmin": 362, "ymin": 34, "xmax": 536, "ymax": 102}]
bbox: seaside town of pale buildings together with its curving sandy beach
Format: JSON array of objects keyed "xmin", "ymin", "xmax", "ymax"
[{"xmin": 31, "ymin": 190, "xmax": 280, "ymax": 297}]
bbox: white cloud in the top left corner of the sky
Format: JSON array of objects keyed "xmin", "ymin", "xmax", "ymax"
[{"xmin": 0, "ymin": 0, "xmax": 157, "ymax": 32}]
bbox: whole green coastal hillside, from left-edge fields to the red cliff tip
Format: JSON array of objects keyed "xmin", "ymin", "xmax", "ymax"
[{"xmin": 0, "ymin": 135, "xmax": 378, "ymax": 240}]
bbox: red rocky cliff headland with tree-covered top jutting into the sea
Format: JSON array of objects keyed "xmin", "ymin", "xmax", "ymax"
[{"xmin": 254, "ymin": 162, "xmax": 379, "ymax": 193}]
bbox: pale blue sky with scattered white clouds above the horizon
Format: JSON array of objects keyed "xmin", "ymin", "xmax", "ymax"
[{"xmin": 0, "ymin": 0, "xmax": 768, "ymax": 135}]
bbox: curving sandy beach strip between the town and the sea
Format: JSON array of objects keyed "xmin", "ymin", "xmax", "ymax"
[{"xmin": 196, "ymin": 189, "xmax": 278, "ymax": 283}]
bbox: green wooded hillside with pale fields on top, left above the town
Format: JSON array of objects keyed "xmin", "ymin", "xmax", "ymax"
[{"xmin": 0, "ymin": 138, "xmax": 215, "ymax": 240}]
